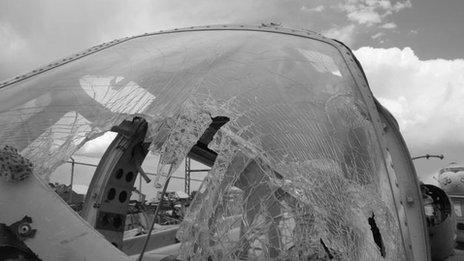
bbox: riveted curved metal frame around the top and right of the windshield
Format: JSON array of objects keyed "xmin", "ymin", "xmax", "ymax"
[{"xmin": 0, "ymin": 25, "xmax": 430, "ymax": 260}]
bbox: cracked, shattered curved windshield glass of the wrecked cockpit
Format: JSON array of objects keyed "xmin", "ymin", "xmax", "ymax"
[{"xmin": 0, "ymin": 31, "xmax": 405, "ymax": 260}]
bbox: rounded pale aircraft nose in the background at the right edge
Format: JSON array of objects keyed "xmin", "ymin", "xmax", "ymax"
[{"xmin": 438, "ymin": 162, "xmax": 464, "ymax": 196}]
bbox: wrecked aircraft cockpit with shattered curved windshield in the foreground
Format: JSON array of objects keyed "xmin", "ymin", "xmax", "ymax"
[{"xmin": 0, "ymin": 25, "xmax": 458, "ymax": 260}]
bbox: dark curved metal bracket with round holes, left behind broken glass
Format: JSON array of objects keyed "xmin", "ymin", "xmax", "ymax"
[{"xmin": 81, "ymin": 117, "xmax": 150, "ymax": 248}]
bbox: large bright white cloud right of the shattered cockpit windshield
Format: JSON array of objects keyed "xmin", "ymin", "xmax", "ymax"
[{"xmin": 355, "ymin": 47, "xmax": 464, "ymax": 146}]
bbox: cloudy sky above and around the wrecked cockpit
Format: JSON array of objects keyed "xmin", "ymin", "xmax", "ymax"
[{"xmin": 0, "ymin": 0, "xmax": 464, "ymax": 183}]
